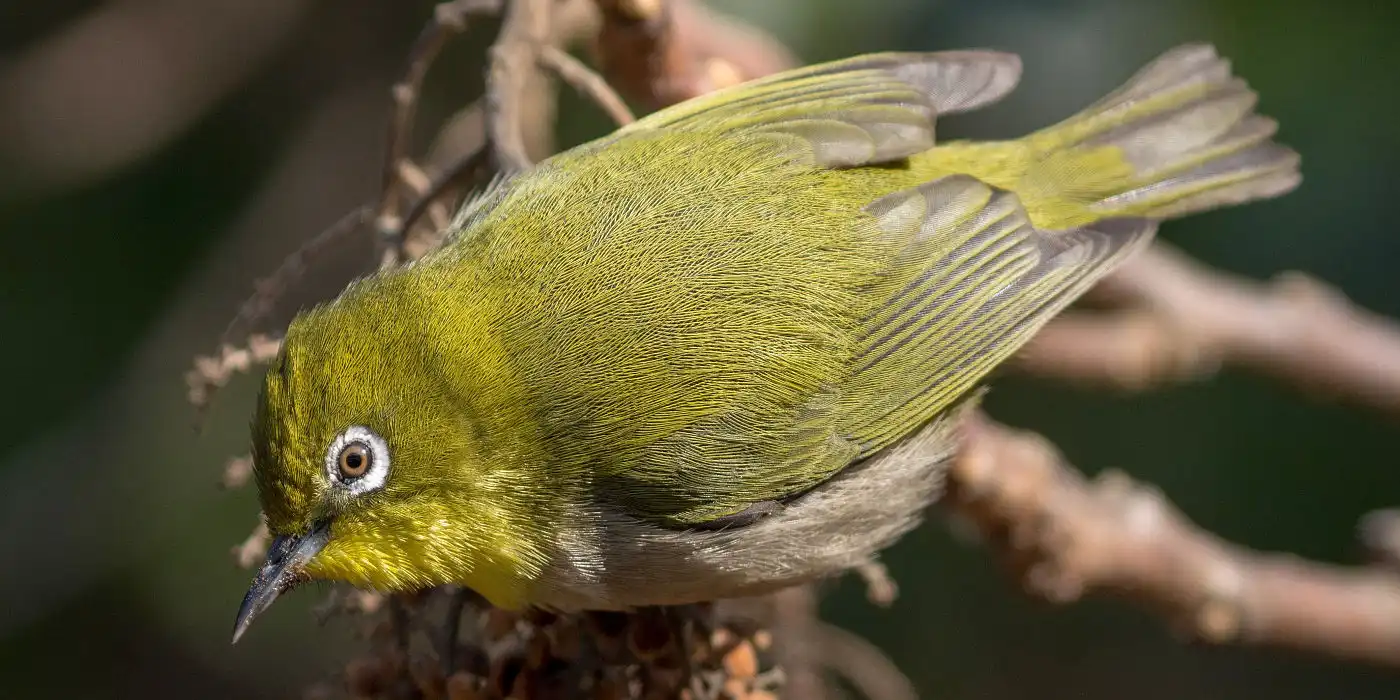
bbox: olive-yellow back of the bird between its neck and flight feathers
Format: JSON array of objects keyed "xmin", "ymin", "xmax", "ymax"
[{"xmin": 439, "ymin": 133, "xmax": 889, "ymax": 524}]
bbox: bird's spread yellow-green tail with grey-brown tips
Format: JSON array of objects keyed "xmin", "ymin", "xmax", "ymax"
[{"xmin": 1015, "ymin": 45, "xmax": 1301, "ymax": 227}]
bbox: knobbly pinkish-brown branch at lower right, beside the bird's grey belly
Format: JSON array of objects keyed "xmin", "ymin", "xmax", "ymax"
[{"xmin": 949, "ymin": 419, "xmax": 1400, "ymax": 666}]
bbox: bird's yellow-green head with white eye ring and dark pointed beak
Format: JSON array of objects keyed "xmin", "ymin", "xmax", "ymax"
[{"xmin": 234, "ymin": 280, "xmax": 539, "ymax": 641}]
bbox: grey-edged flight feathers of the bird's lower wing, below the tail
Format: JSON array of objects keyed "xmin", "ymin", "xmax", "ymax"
[{"xmin": 837, "ymin": 175, "xmax": 1156, "ymax": 456}]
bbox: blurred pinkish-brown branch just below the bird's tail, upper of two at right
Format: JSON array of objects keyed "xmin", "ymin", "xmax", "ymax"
[{"xmin": 1018, "ymin": 244, "xmax": 1400, "ymax": 414}]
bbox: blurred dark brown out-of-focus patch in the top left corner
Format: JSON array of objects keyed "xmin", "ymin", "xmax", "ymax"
[{"xmin": 0, "ymin": 0, "xmax": 314, "ymax": 196}]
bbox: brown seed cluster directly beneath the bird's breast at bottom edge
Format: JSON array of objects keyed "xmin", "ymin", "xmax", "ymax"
[{"xmin": 307, "ymin": 591, "xmax": 784, "ymax": 700}]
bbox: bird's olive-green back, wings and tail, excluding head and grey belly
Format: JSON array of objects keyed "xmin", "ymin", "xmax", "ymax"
[{"xmin": 403, "ymin": 48, "xmax": 1296, "ymax": 525}]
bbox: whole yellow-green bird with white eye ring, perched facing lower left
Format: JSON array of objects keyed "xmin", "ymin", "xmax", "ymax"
[{"xmin": 234, "ymin": 45, "xmax": 1299, "ymax": 640}]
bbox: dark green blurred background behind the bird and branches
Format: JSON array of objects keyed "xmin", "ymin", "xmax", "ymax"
[{"xmin": 0, "ymin": 0, "xmax": 1400, "ymax": 700}]
